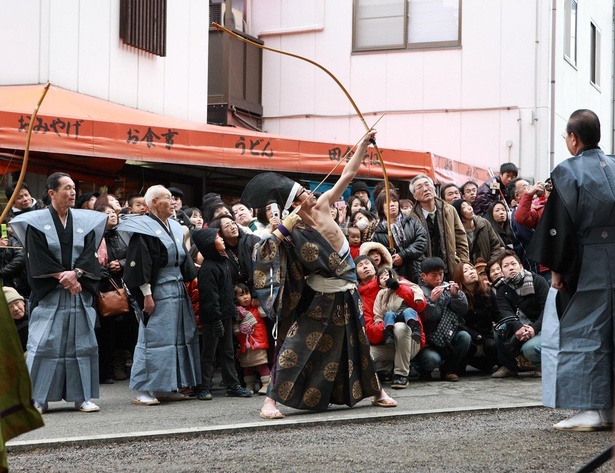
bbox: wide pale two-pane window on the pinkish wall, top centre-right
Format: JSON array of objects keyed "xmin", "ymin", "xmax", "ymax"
[{"xmin": 353, "ymin": 0, "xmax": 461, "ymax": 51}]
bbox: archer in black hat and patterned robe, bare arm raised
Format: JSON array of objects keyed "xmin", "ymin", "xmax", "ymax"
[{"xmin": 242, "ymin": 133, "xmax": 397, "ymax": 419}]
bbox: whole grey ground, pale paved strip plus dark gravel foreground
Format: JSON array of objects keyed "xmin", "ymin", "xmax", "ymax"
[{"xmin": 9, "ymin": 373, "xmax": 612, "ymax": 473}]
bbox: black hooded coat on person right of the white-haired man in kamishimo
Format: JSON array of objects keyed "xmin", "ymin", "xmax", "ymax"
[{"xmin": 192, "ymin": 228, "xmax": 237, "ymax": 325}]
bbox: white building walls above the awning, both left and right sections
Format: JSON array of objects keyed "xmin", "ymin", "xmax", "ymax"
[{"xmin": 0, "ymin": 0, "xmax": 615, "ymax": 183}]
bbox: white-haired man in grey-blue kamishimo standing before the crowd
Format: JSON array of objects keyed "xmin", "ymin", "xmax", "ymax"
[{"xmin": 117, "ymin": 185, "xmax": 201, "ymax": 406}]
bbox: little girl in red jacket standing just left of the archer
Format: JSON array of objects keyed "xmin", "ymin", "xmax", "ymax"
[{"xmin": 233, "ymin": 283, "xmax": 271, "ymax": 395}]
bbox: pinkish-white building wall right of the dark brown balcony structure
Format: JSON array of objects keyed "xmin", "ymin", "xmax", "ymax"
[{"xmin": 247, "ymin": 0, "xmax": 614, "ymax": 179}]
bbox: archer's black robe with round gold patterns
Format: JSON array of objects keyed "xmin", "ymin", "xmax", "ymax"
[{"xmin": 254, "ymin": 224, "xmax": 380, "ymax": 410}]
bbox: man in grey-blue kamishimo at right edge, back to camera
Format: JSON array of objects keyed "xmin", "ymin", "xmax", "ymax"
[{"xmin": 530, "ymin": 110, "xmax": 615, "ymax": 431}]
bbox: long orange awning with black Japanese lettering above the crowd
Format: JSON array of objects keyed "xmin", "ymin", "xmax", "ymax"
[{"xmin": 0, "ymin": 85, "xmax": 442, "ymax": 180}]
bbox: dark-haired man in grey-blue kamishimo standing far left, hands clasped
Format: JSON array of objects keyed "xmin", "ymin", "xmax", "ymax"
[{"xmin": 10, "ymin": 172, "xmax": 107, "ymax": 413}]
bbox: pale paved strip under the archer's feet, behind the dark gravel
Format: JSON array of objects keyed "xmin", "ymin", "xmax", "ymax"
[{"xmin": 7, "ymin": 372, "xmax": 542, "ymax": 452}]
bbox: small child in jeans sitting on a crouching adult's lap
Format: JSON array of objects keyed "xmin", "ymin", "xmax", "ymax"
[{"xmin": 374, "ymin": 268, "xmax": 426, "ymax": 346}]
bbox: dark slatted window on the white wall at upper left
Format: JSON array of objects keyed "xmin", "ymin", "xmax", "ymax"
[{"xmin": 120, "ymin": 0, "xmax": 167, "ymax": 56}]
